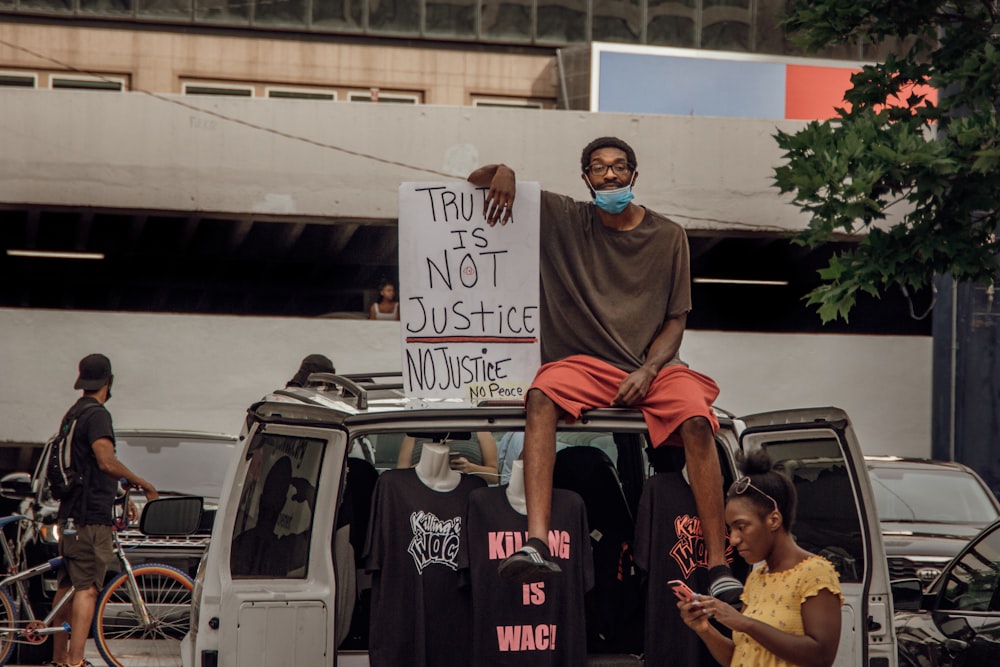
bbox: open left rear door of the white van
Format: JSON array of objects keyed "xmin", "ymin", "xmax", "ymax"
[{"xmin": 182, "ymin": 420, "xmax": 354, "ymax": 667}]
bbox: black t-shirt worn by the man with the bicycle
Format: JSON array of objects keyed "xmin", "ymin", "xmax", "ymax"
[{"xmin": 59, "ymin": 396, "xmax": 118, "ymax": 526}]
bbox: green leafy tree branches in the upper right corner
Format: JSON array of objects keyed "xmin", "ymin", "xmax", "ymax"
[{"xmin": 775, "ymin": 0, "xmax": 1000, "ymax": 322}]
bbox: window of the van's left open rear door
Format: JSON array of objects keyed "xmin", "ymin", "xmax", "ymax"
[{"xmin": 229, "ymin": 433, "xmax": 326, "ymax": 579}]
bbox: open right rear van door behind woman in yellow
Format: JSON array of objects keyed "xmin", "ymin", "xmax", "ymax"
[{"xmin": 737, "ymin": 408, "xmax": 897, "ymax": 667}]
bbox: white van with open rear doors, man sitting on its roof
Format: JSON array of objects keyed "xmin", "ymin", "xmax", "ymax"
[{"xmin": 182, "ymin": 374, "xmax": 896, "ymax": 667}]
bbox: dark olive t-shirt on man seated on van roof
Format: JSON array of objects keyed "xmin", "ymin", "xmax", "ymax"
[{"xmin": 539, "ymin": 192, "xmax": 691, "ymax": 372}]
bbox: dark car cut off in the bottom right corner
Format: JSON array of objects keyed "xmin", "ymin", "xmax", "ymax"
[{"xmin": 893, "ymin": 521, "xmax": 1000, "ymax": 667}]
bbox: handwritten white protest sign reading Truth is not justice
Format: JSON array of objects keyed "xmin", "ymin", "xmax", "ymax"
[{"xmin": 399, "ymin": 181, "xmax": 541, "ymax": 403}]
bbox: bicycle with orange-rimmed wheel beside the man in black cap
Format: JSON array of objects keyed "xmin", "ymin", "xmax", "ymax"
[{"xmin": 0, "ymin": 489, "xmax": 193, "ymax": 667}]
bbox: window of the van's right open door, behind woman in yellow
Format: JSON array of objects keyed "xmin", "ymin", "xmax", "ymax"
[{"xmin": 767, "ymin": 438, "xmax": 865, "ymax": 583}]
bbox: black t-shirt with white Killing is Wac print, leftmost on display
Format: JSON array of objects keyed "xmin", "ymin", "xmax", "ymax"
[{"xmin": 365, "ymin": 468, "xmax": 486, "ymax": 667}]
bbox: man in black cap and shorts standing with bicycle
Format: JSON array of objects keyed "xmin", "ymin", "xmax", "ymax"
[{"xmin": 52, "ymin": 354, "xmax": 158, "ymax": 667}]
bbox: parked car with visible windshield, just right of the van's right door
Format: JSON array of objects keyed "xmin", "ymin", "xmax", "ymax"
[{"xmin": 865, "ymin": 456, "xmax": 1000, "ymax": 586}]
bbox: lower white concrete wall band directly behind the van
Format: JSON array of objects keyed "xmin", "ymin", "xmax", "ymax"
[{"xmin": 0, "ymin": 309, "xmax": 931, "ymax": 456}]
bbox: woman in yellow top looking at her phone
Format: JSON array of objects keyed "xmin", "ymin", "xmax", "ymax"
[{"xmin": 678, "ymin": 450, "xmax": 843, "ymax": 667}]
